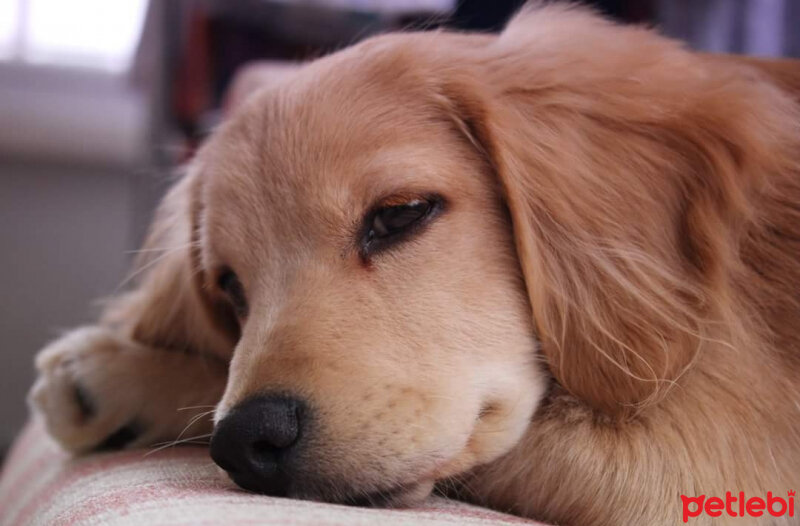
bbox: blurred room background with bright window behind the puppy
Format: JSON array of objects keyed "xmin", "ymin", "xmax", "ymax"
[{"xmin": 0, "ymin": 0, "xmax": 800, "ymax": 454}]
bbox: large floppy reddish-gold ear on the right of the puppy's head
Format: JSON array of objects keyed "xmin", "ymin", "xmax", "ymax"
[{"xmin": 438, "ymin": 7, "xmax": 796, "ymax": 416}]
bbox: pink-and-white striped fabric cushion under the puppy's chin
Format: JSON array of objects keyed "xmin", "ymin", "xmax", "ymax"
[{"xmin": 0, "ymin": 423, "xmax": 539, "ymax": 526}]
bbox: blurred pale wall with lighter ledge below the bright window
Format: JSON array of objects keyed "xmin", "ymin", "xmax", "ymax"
[{"xmin": 0, "ymin": 53, "xmax": 159, "ymax": 450}]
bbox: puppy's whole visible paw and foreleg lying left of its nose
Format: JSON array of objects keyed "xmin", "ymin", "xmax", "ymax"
[{"xmin": 28, "ymin": 327, "xmax": 227, "ymax": 453}]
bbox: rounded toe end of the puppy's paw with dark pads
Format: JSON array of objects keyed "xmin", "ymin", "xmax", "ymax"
[{"xmin": 28, "ymin": 327, "xmax": 153, "ymax": 452}]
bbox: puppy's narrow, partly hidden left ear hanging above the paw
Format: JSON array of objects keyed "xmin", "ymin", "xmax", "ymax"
[{"xmin": 103, "ymin": 168, "xmax": 239, "ymax": 356}]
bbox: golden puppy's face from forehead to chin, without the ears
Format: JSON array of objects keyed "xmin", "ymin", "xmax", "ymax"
[{"xmin": 196, "ymin": 29, "xmax": 545, "ymax": 508}]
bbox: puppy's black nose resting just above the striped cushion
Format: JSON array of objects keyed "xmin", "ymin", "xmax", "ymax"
[{"xmin": 211, "ymin": 396, "xmax": 304, "ymax": 495}]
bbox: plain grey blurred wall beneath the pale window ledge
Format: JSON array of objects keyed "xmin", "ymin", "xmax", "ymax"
[{"xmin": 0, "ymin": 161, "xmax": 135, "ymax": 447}]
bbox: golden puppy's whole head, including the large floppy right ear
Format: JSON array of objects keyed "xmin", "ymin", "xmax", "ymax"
[{"xmin": 128, "ymin": 3, "xmax": 790, "ymax": 503}]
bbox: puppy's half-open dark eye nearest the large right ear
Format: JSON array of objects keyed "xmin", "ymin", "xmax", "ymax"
[{"xmin": 362, "ymin": 197, "xmax": 441, "ymax": 255}]
